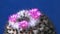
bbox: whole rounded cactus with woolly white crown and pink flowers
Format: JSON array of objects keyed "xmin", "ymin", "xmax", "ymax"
[{"xmin": 4, "ymin": 8, "xmax": 56, "ymax": 34}]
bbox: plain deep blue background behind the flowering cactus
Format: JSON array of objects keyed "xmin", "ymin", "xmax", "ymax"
[{"xmin": 0, "ymin": 0, "xmax": 60, "ymax": 34}]
